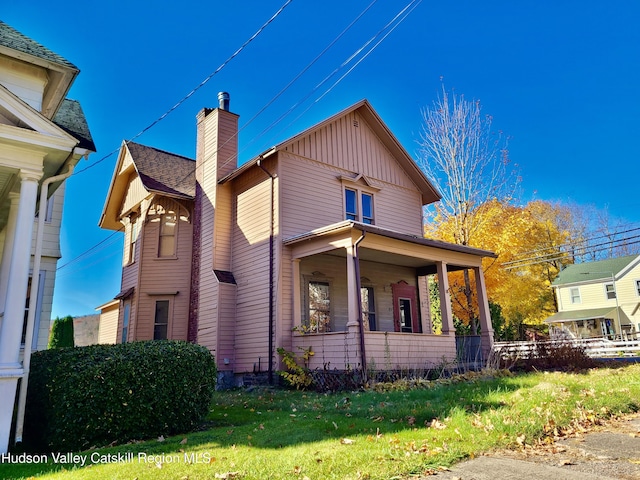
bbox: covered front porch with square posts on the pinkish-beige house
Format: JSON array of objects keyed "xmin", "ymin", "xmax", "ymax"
[{"xmin": 284, "ymin": 221, "xmax": 494, "ymax": 371}]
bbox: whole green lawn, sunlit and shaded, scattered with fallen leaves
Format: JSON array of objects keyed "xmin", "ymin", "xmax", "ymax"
[{"xmin": 5, "ymin": 365, "xmax": 640, "ymax": 480}]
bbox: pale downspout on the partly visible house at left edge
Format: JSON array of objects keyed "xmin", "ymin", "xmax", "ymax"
[{"xmin": 15, "ymin": 148, "xmax": 78, "ymax": 443}]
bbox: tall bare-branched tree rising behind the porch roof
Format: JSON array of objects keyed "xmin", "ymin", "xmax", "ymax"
[{"xmin": 418, "ymin": 86, "xmax": 519, "ymax": 334}]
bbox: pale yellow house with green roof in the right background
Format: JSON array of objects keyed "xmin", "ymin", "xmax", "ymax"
[{"xmin": 545, "ymin": 255, "xmax": 640, "ymax": 340}]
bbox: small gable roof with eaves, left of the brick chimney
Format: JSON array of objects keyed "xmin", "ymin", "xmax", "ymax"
[{"xmin": 98, "ymin": 142, "xmax": 196, "ymax": 230}]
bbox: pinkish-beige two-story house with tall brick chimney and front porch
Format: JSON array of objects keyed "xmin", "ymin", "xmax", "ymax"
[{"xmin": 100, "ymin": 93, "xmax": 493, "ymax": 382}]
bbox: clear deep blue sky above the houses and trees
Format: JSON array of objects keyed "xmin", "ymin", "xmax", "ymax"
[{"xmin": 0, "ymin": 0, "xmax": 640, "ymax": 317}]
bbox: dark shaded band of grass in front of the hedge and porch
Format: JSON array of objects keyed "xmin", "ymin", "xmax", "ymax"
[{"xmin": 0, "ymin": 377, "xmax": 535, "ymax": 478}]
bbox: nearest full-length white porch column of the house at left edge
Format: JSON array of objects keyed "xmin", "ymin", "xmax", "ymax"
[{"xmin": 0, "ymin": 171, "xmax": 44, "ymax": 454}]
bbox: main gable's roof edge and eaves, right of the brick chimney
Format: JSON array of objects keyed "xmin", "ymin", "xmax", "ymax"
[{"xmin": 220, "ymin": 100, "xmax": 441, "ymax": 205}]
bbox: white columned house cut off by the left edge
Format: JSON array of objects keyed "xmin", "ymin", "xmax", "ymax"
[{"xmin": 0, "ymin": 22, "xmax": 95, "ymax": 453}]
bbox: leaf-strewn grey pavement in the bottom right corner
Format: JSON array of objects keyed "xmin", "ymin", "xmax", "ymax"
[{"xmin": 430, "ymin": 413, "xmax": 640, "ymax": 480}]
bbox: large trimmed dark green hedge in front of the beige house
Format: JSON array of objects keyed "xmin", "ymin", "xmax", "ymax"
[{"xmin": 24, "ymin": 340, "xmax": 216, "ymax": 452}]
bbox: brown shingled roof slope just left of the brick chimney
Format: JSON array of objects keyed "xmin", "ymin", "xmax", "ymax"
[{"xmin": 127, "ymin": 142, "xmax": 196, "ymax": 199}]
